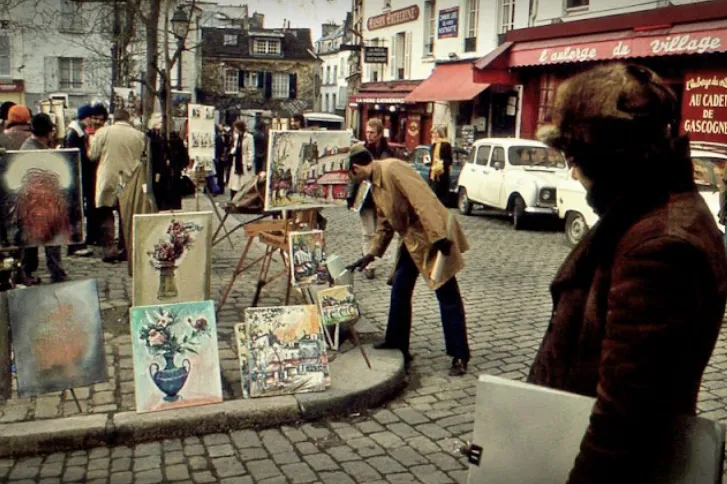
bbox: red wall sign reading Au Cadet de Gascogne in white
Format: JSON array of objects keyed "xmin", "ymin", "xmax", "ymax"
[{"xmin": 681, "ymin": 72, "xmax": 727, "ymax": 143}]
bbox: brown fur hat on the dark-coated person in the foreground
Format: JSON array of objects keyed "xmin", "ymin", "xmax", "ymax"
[{"xmin": 537, "ymin": 63, "xmax": 679, "ymax": 152}]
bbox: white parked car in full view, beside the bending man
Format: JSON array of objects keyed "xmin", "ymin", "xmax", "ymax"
[{"xmin": 457, "ymin": 138, "xmax": 568, "ymax": 230}]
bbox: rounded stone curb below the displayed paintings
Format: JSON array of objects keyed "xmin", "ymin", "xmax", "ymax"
[{"xmin": 0, "ymin": 345, "xmax": 406, "ymax": 457}]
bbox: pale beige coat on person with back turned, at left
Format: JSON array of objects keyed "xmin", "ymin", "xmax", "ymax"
[{"xmin": 89, "ymin": 121, "xmax": 146, "ymax": 207}]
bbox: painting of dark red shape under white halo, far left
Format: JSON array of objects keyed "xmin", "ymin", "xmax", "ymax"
[{"xmin": 0, "ymin": 150, "xmax": 85, "ymax": 247}]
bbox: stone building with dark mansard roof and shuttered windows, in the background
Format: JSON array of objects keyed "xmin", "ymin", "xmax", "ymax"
[{"xmin": 197, "ymin": 28, "xmax": 321, "ymax": 121}]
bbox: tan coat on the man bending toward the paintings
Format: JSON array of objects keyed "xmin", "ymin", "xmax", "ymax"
[{"xmin": 369, "ymin": 159, "xmax": 469, "ymax": 289}]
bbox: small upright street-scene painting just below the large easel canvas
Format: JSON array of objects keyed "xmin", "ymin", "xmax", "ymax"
[{"xmin": 288, "ymin": 230, "xmax": 329, "ymax": 287}]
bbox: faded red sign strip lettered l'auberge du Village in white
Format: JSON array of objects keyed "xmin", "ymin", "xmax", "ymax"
[{"xmin": 510, "ymin": 29, "xmax": 727, "ymax": 67}]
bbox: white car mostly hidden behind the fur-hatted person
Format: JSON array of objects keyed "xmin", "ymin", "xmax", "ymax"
[{"xmin": 557, "ymin": 143, "xmax": 727, "ymax": 246}]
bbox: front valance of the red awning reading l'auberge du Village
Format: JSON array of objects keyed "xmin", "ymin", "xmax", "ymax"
[{"xmin": 510, "ymin": 20, "xmax": 727, "ymax": 67}]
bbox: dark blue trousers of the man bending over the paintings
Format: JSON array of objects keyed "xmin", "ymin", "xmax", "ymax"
[{"xmin": 386, "ymin": 246, "xmax": 470, "ymax": 361}]
